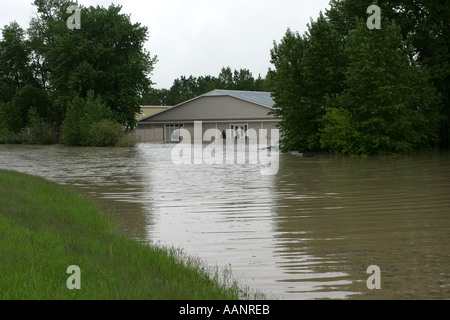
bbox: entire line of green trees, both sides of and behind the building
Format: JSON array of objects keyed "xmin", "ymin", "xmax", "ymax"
[{"xmin": 0, "ymin": 0, "xmax": 450, "ymax": 155}]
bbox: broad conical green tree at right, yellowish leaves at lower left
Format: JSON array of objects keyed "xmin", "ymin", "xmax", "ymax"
[{"xmin": 322, "ymin": 20, "xmax": 439, "ymax": 155}]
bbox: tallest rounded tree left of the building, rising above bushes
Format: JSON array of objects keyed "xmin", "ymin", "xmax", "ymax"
[{"xmin": 30, "ymin": 1, "xmax": 156, "ymax": 130}]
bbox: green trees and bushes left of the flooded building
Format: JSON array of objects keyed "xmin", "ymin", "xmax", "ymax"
[{"xmin": 0, "ymin": 0, "xmax": 156, "ymax": 146}]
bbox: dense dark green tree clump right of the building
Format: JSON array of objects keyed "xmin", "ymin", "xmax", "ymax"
[{"xmin": 268, "ymin": 0, "xmax": 450, "ymax": 155}]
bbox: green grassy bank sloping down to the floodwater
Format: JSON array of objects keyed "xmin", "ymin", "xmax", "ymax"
[{"xmin": 0, "ymin": 170, "xmax": 250, "ymax": 300}]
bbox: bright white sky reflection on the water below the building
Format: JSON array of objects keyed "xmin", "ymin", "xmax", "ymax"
[{"xmin": 139, "ymin": 145, "xmax": 277, "ymax": 293}]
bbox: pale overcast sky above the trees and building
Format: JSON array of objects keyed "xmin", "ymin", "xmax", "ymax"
[{"xmin": 0, "ymin": 0, "xmax": 329, "ymax": 88}]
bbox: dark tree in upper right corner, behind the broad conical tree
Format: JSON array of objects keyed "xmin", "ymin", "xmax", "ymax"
[{"xmin": 327, "ymin": 0, "xmax": 450, "ymax": 144}]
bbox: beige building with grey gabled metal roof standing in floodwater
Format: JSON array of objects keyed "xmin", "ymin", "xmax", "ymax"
[{"xmin": 136, "ymin": 90, "xmax": 279, "ymax": 142}]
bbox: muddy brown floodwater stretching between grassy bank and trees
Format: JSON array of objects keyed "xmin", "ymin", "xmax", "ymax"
[{"xmin": 0, "ymin": 144, "xmax": 450, "ymax": 299}]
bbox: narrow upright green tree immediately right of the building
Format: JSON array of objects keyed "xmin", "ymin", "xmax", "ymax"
[{"xmin": 270, "ymin": 14, "xmax": 346, "ymax": 151}]
